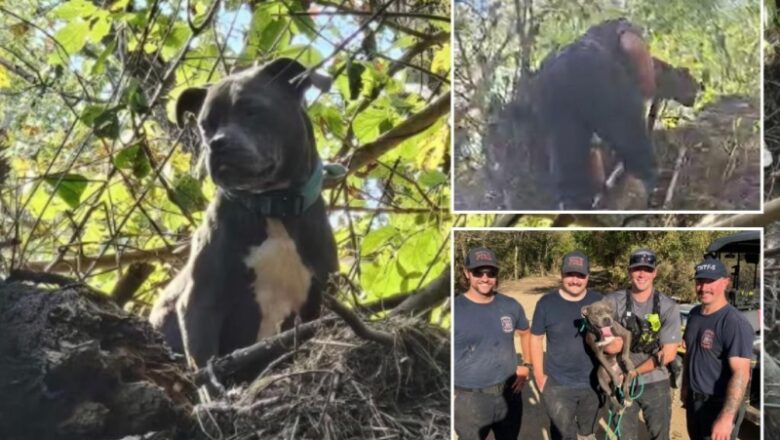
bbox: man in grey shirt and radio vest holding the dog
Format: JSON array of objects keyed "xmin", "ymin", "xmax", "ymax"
[{"xmin": 607, "ymin": 249, "xmax": 680, "ymax": 440}]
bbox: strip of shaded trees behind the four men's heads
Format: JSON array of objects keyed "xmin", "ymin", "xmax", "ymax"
[{"xmin": 455, "ymin": 230, "xmax": 755, "ymax": 302}]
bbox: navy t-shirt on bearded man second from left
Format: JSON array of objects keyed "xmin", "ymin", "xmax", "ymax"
[{"xmin": 531, "ymin": 289, "xmax": 601, "ymax": 386}]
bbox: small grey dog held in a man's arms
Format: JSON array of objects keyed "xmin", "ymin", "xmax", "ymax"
[{"xmin": 582, "ymin": 300, "xmax": 634, "ymax": 412}]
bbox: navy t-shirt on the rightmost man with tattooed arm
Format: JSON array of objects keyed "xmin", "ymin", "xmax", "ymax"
[{"xmin": 683, "ymin": 304, "xmax": 753, "ymax": 397}]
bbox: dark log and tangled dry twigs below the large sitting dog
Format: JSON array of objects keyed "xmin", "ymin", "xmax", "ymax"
[{"xmin": 0, "ymin": 276, "xmax": 450, "ymax": 439}]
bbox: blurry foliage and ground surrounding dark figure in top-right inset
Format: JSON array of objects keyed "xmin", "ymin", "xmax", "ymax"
[{"xmin": 453, "ymin": 0, "xmax": 761, "ymax": 211}]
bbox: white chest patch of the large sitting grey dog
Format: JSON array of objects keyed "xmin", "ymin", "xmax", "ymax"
[{"xmin": 244, "ymin": 219, "xmax": 312, "ymax": 340}]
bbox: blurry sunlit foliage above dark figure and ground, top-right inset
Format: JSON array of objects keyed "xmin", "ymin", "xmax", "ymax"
[{"xmin": 454, "ymin": 0, "xmax": 761, "ymax": 166}]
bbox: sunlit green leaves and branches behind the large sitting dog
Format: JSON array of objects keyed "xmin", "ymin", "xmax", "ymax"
[{"xmin": 0, "ymin": 0, "xmax": 450, "ymax": 322}]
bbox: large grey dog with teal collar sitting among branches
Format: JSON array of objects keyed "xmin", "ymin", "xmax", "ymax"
[{"xmin": 150, "ymin": 59, "xmax": 338, "ymax": 368}]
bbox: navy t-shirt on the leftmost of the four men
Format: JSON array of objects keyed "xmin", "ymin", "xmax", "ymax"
[{"xmin": 453, "ymin": 293, "xmax": 528, "ymax": 388}]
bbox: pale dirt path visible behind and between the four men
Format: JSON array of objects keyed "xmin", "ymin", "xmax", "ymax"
[{"xmin": 499, "ymin": 275, "xmax": 759, "ymax": 440}]
